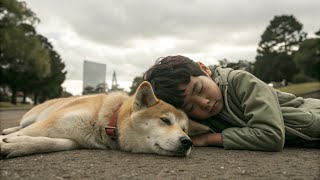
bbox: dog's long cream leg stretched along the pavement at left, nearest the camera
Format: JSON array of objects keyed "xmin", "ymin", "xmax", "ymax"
[{"xmin": 0, "ymin": 136, "xmax": 79, "ymax": 158}]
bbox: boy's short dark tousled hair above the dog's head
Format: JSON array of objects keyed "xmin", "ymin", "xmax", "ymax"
[{"xmin": 143, "ymin": 55, "xmax": 205, "ymax": 107}]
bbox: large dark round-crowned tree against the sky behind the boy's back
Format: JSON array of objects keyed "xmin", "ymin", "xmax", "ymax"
[{"xmin": 253, "ymin": 15, "xmax": 307, "ymax": 82}]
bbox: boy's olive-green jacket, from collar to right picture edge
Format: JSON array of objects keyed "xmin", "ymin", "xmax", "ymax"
[{"xmin": 202, "ymin": 67, "xmax": 320, "ymax": 151}]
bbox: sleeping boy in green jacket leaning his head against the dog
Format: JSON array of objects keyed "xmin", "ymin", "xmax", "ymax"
[{"xmin": 144, "ymin": 56, "xmax": 320, "ymax": 151}]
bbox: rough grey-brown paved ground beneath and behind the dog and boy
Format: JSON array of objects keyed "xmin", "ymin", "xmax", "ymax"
[{"xmin": 0, "ymin": 110, "xmax": 320, "ymax": 180}]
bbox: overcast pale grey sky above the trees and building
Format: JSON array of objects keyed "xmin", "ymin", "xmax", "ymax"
[{"xmin": 26, "ymin": 0, "xmax": 320, "ymax": 94}]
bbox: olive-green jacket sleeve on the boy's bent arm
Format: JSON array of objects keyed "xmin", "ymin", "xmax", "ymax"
[{"xmin": 222, "ymin": 71, "xmax": 285, "ymax": 151}]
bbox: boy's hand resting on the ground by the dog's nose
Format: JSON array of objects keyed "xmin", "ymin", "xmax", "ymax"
[{"xmin": 191, "ymin": 133, "xmax": 222, "ymax": 146}]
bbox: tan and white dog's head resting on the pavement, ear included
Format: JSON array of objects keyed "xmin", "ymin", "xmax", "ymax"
[{"xmin": 119, "ymin": 81, "xmax": 192, "ymax": 156}]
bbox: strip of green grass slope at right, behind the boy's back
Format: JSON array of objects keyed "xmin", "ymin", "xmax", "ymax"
[{"xmin": 276, "ymin": 82, "xmax": 320, "ymax": 95}]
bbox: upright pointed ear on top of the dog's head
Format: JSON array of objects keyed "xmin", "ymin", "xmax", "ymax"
[{"xmin": 133, "ymin": 81, "xmax": 159, "ymax": 111}]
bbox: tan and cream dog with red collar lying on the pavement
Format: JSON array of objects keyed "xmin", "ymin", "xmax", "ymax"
[{"xmin": 0, "ymin": 81, "xmax": 196, "ymax": 158}]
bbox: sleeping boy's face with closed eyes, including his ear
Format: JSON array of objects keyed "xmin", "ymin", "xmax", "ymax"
[{"xmin": 179, "ymin": 62, "xmax": 223, "ymax": 120}]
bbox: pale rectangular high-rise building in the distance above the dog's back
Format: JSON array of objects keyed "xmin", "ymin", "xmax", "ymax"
[{"xmin": 82, "ymin": 60, "xmax": 108, "ymax": 95}]
